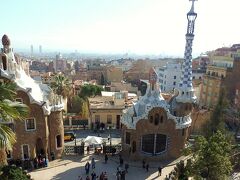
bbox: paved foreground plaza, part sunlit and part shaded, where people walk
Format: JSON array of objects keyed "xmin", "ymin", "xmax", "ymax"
[{"xmin": 30, "ymin": 155, "xmax": 188, "ymax": 180}]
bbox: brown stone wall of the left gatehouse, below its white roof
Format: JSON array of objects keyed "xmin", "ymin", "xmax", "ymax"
[{"xmin": 8, "ymin": 91, "xmax": 64, "ymax": 159}]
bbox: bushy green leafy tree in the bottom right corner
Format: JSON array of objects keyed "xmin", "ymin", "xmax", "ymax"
[{"xmin": 192, "ymin": 131, "xmax": 232, "ymax": 180}]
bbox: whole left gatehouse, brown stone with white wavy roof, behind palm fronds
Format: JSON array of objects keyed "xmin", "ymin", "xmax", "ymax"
[{"xmin": 0, "ymin": 35, "xmax": 64, "ymax": 160}]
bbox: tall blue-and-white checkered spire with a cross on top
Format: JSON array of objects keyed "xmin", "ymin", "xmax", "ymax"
[{"xmin": 176, "ymin": 0, "xmax": 197, "ymax": 103}]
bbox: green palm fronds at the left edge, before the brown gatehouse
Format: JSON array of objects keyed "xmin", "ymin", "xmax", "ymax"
[{"xmin": 0, "ymin": 82, "xmax": 29, "ymax": 165}]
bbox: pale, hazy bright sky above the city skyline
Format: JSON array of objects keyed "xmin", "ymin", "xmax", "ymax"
[{"xmin": 0, "ymin": 0, "xmax": 240, "ymax": 57}]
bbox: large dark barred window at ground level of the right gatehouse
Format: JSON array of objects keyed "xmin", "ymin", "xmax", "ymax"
[{"xmin": 142, "ymin": 134, "xmax": 167, "ymax": 155}]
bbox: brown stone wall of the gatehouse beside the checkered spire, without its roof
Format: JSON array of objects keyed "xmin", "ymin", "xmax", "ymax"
[{"xmin": 122, "ymin": 108, "xmax": 189, "ymax": 161}]
